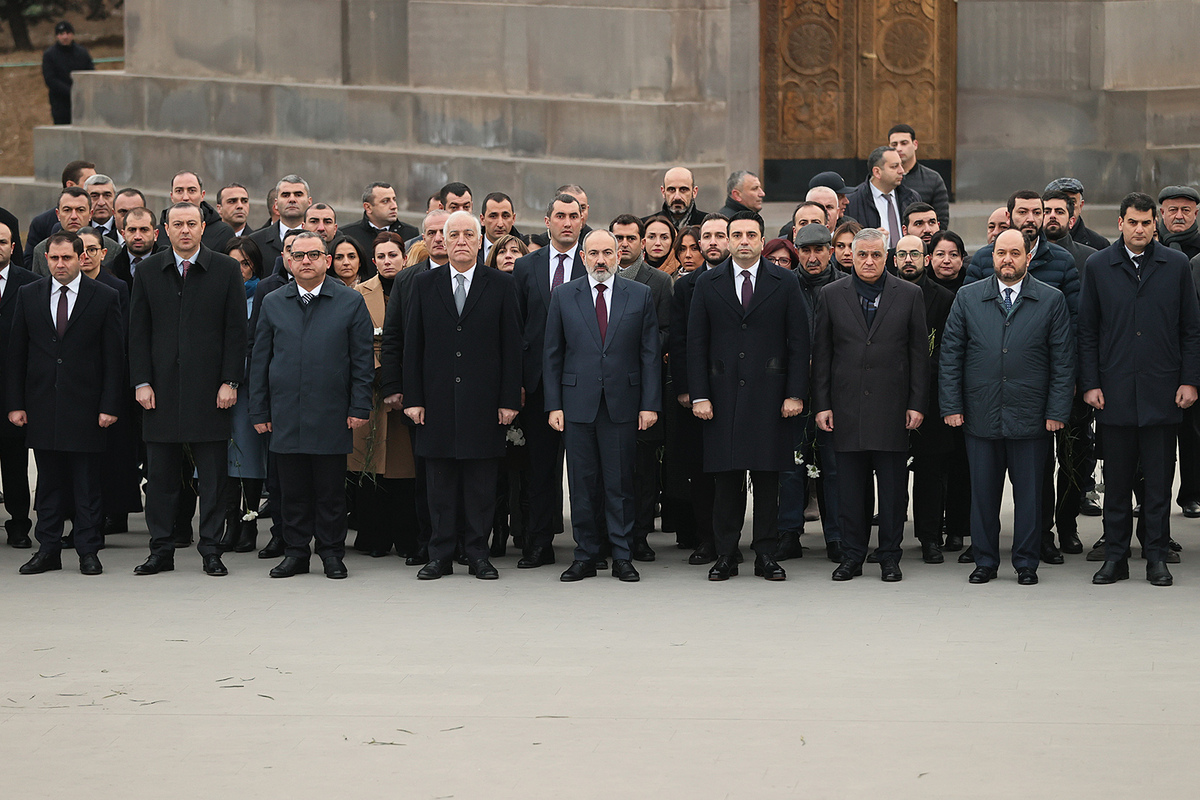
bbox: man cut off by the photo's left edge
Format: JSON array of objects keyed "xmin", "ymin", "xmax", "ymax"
[{"xmin": 0, "ymin": 223, "xmax": 37, "ymax": 549}]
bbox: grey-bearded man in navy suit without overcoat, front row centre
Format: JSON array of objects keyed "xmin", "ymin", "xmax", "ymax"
[{"xmin": 542, "ymin": 230, "xmax": 662, "ymax": 582}]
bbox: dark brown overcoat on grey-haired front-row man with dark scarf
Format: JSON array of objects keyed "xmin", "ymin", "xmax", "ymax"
[{"xmin": 812, "ymin": 272, "xmax": 929, "ymax": 452}]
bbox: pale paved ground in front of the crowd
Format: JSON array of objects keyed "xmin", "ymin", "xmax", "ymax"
[{"xmin": 0, "ymin": 491, "xmax": 1200, "ymax": 800}]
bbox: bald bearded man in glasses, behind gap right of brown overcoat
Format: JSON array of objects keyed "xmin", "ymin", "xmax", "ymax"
[{"xmin": 895, "ymin": 235, "xmax": 954, "ymax": 564}]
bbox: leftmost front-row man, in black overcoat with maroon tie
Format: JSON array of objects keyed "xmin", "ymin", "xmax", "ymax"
[{"xmin": 5, "ymin": 233, "xmax": 125, "ymax": 575}]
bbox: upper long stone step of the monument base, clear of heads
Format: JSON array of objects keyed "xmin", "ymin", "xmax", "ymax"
[{"xmin": 72, "ymin": 72, "xmax": 725, "ymax": 172}]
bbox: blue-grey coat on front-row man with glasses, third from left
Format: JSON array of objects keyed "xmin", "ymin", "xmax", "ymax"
[{"xmin": 250, "ymin": 278, "xmax": 374, "ymax": 456}]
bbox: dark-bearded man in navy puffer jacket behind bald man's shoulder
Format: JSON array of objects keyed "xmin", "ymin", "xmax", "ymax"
[{"xmin": 965, "ymin": 190, "xmax": 1082, "ymax": 564}]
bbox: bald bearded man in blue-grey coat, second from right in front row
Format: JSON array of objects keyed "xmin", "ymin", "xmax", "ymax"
[{"xmin": 938, "ymin": 228, "xmax": 1075, "ymax": 585}]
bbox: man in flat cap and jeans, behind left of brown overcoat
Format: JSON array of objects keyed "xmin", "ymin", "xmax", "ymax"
[{"xmin": 775, "ymin": 224, "xmax": 844, "ymax": 564}]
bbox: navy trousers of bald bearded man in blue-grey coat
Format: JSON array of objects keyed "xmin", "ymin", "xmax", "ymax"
[{"xmin": 965, "ymin": 433, "xmax": 1052, "ymax": 570}]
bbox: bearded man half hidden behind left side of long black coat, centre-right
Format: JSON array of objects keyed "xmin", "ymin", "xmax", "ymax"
[{"xmin": 668, "ymin": 213, "xmax": 745, "ymax": 566}]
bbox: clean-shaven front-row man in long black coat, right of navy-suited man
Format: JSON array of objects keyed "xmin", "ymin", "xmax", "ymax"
[{"xmin": 688, "ymin": 211, "xmax": 809, "ymax": 581}]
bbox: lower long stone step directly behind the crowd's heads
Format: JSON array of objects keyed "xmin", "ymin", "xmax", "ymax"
[{"xmin": 25, "ymin": 125, "xmax": 726, "ymax": 229}]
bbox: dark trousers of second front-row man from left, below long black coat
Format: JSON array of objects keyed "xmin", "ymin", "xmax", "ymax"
[{"xmin": 145, "ymin": 441, "xmax": 226, "ymax": 559}]
